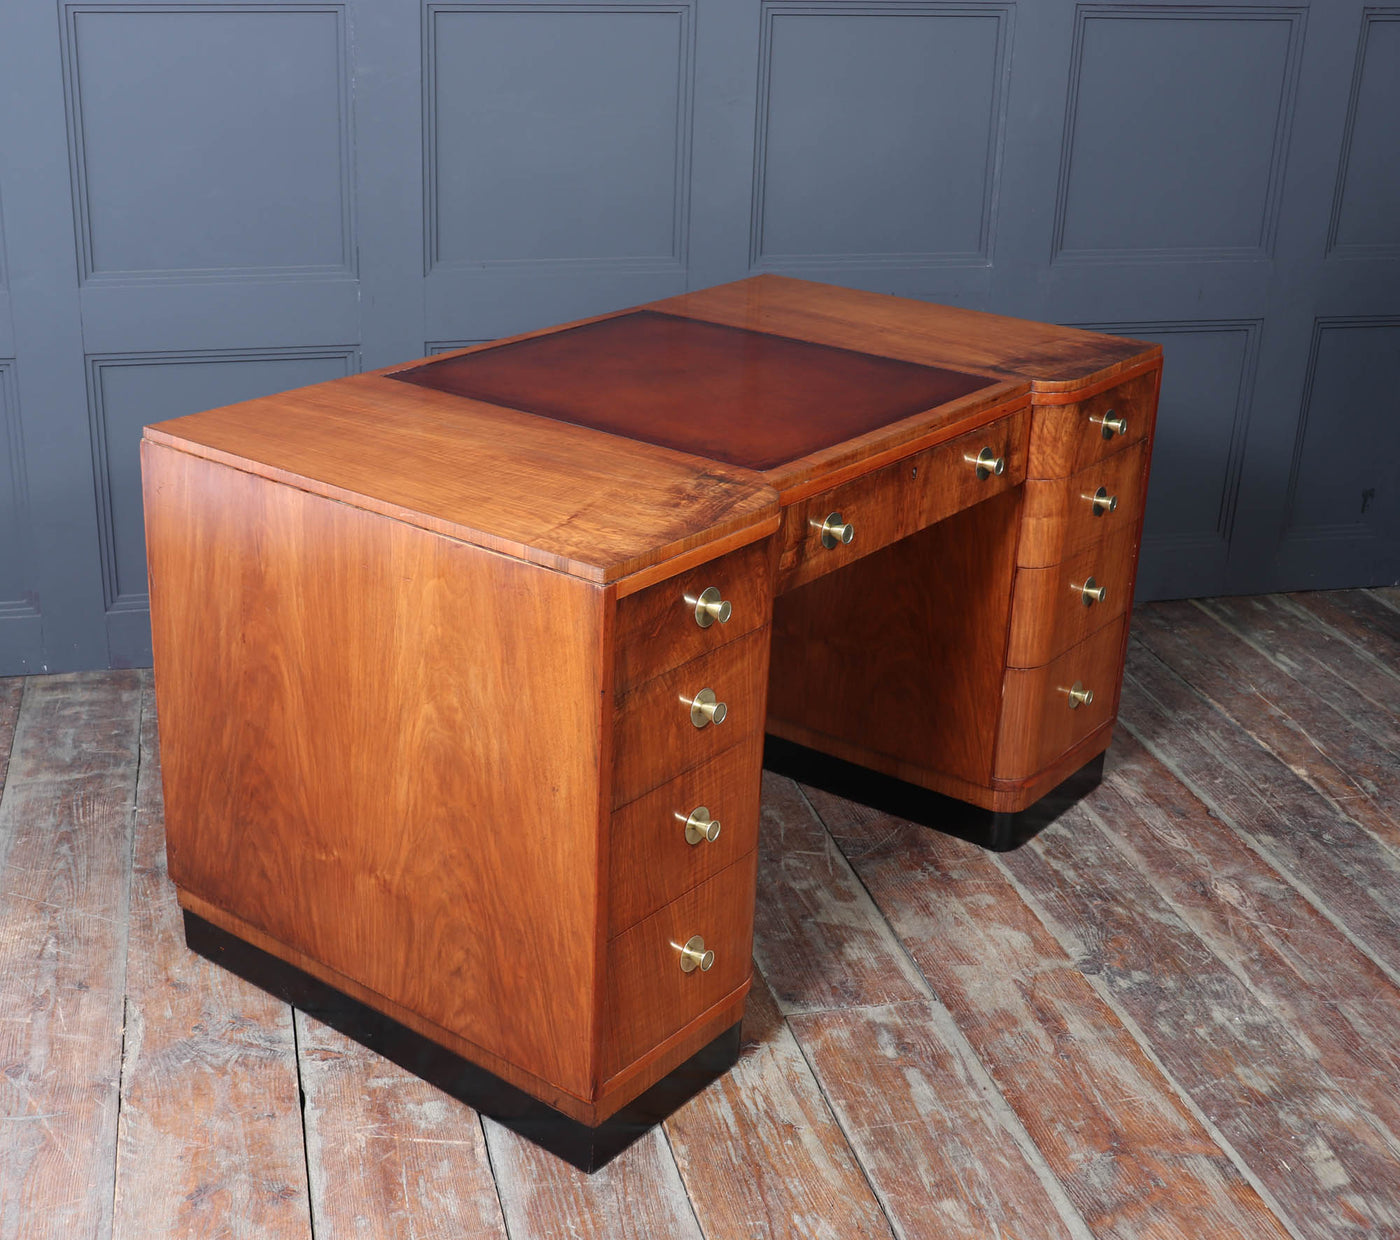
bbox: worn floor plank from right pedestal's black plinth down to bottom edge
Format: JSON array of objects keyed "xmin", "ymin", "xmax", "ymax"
[{"xmin": 809, "ymin": 791, "xmax": 1287, "ymax": 1240}]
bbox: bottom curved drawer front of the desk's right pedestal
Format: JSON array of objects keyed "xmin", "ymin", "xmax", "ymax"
[{"xmin": 994, "ymin": 616, "xmax": 1126, "ymax": 780}]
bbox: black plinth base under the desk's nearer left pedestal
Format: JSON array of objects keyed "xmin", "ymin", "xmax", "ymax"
[{"xmin": 185, "ymin": 913, "xmax": 739, "ymax": 1171}]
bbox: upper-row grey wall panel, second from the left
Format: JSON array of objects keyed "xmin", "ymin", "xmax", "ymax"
[{"xmin": 424, "ymin": 4, "xmax": 690, "ymax": 270}]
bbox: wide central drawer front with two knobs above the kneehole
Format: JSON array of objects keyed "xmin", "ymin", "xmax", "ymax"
[{"xmin": 777, "ymin": 410, "xmax": 1029, "ymax": 593}]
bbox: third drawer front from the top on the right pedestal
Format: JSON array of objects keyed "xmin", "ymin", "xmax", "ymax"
[{"xmin": 1007, "ymin": 523, "xmax": 1137, "ymax": 668}]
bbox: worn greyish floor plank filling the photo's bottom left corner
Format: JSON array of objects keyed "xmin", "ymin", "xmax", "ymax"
[{"xmin": 0, "ymin": 672, "xmax": 141, "ymax": 1240}]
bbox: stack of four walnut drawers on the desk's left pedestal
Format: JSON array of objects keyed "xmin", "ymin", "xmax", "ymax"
[{"xmin": 601, "ymin": 539, "xmax": 773, "ymax": 1092}]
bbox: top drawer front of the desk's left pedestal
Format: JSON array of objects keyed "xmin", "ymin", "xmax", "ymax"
[{"xmin": 615, "ymin": 539, "xmax": 773, "ymax": 694}]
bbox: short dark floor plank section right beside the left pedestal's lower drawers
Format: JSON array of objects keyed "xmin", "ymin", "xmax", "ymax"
[{"xmin": 753, "ymin": 771, "xmax": 928, "ymax": 1013}]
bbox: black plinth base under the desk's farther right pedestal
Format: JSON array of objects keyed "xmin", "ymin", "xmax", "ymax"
[{"xmin": 763, "ymin": 736, "xmax": 1103, "ymax": 852}]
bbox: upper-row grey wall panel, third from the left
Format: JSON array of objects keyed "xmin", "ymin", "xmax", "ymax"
[{"xmin": 750, "ymin": 4, "xmax": 1012, "ymax": 276}]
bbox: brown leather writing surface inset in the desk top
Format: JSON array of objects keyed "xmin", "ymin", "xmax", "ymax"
[{"xmin": 389, "ymin": 311, "xmax": 995, "ymax": 469}]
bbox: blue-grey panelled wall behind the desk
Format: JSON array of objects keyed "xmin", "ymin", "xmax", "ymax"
[{"xmin": 0, "ymin": 0, "xmax": 1400, "ymax": 672}]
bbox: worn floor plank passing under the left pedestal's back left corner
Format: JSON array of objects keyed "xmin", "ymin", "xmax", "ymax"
[{"xmin": 113, "ymin": 680, "xmax": 311, "ymax": 1240}]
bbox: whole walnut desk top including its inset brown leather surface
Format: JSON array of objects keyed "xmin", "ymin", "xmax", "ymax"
[{"xmin": 146, "ymin": 276, "xmax": 1161, "ymax": 585}]
